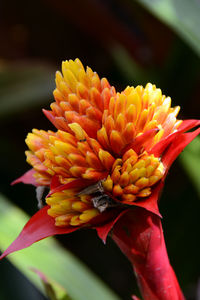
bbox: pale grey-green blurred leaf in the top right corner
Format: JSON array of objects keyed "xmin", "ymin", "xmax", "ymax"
[{"xmin": 137, "ymin": 0, "xmax": 200, "ymax": 55}]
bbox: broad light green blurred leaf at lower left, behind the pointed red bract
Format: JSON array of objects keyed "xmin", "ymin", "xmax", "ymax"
[{"xmin": 0, "ymin": 195, "xmax": 119, "ymax": 300}]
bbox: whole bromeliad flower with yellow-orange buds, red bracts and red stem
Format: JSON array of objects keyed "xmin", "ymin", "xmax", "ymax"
[{"xmin": 1, "ymin": 59, "xmax": 200, "ymax": 300}]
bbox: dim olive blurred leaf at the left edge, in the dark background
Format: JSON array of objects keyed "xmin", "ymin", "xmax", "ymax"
[{"xmin": 0, "ymin": 63, "xmax": 55, "ymax": 118}]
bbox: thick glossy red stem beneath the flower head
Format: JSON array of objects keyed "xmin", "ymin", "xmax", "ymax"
[{"xmin": 112, "ymin": 208, "xmax": 185, "ymax": 300}]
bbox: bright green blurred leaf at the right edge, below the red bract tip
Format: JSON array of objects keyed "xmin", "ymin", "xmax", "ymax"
[{"xmin": 180, "ymin": 137, "xmax": 200, "ymax": 195}]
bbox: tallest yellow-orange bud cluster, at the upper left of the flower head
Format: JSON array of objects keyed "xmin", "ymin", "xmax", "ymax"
[{"xmin": 44, "ymin": 59, "xmax": 116, "ymax": 138}]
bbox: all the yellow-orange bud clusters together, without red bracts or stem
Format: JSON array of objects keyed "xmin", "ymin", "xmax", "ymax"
[{"xmin": 26, "ymin": 59, "xmax": 181, "ymax": 226}]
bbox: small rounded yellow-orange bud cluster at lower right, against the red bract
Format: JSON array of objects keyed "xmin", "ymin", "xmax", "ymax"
[{"xmin": 102, "ymin": 149, "xmax": 164, "ymax": 204}]
